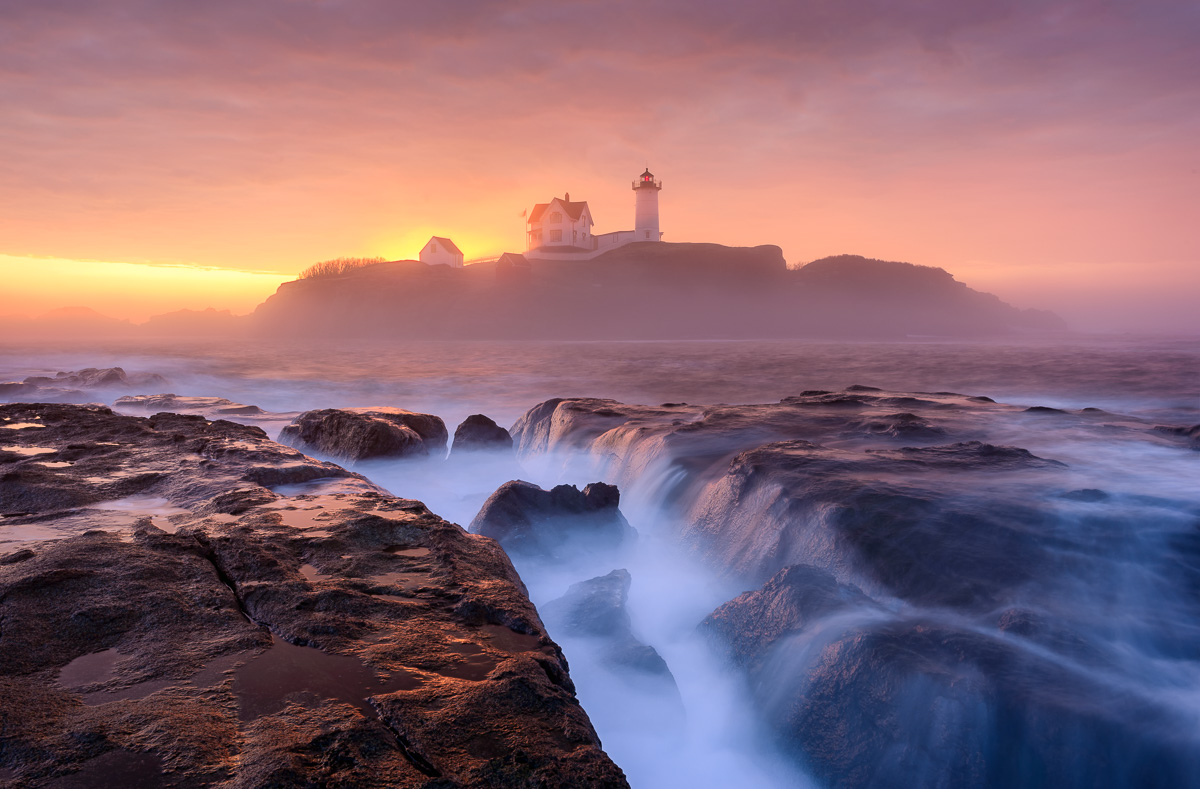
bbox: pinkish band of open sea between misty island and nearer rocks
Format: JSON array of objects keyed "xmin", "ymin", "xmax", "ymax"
[{"xmin": 0, "ymin": 337, "xmax": 1200, "ymax": 424}]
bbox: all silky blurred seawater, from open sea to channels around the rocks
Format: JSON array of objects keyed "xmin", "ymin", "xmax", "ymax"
[{"xmin": 0, "ymin": 337, "xmax": 1200, "ymax": 789}]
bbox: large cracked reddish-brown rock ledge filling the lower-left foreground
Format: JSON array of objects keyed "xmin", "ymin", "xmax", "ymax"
[{"xmin": 0, "ymin": 404, "xmax": 628, "ymax": 788}]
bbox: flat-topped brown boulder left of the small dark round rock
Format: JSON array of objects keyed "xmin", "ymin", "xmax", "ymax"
[{"xmin": 280, "ymin": 408, "xmax": 448, "ymax": 460}]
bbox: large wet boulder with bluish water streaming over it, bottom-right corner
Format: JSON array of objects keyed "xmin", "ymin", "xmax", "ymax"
[{"xmin": 702, "ymin": 566, "xmax": 1200, "ymax": 788}]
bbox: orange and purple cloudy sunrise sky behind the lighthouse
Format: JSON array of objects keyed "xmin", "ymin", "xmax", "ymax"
[{"xmin": 0, "ymin": 0, "xmax": 1200, "ymax": 331}]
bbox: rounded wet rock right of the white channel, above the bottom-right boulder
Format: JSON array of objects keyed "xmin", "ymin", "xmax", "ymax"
[{"xmin": 685, "ymin": 441, "xmax": 1060, "ymax": 607}]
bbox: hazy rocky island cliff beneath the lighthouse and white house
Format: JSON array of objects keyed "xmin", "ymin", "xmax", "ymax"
[{"xmin": 253, "ymin": 243, "xmax": 1062, "ymax": 339}]
